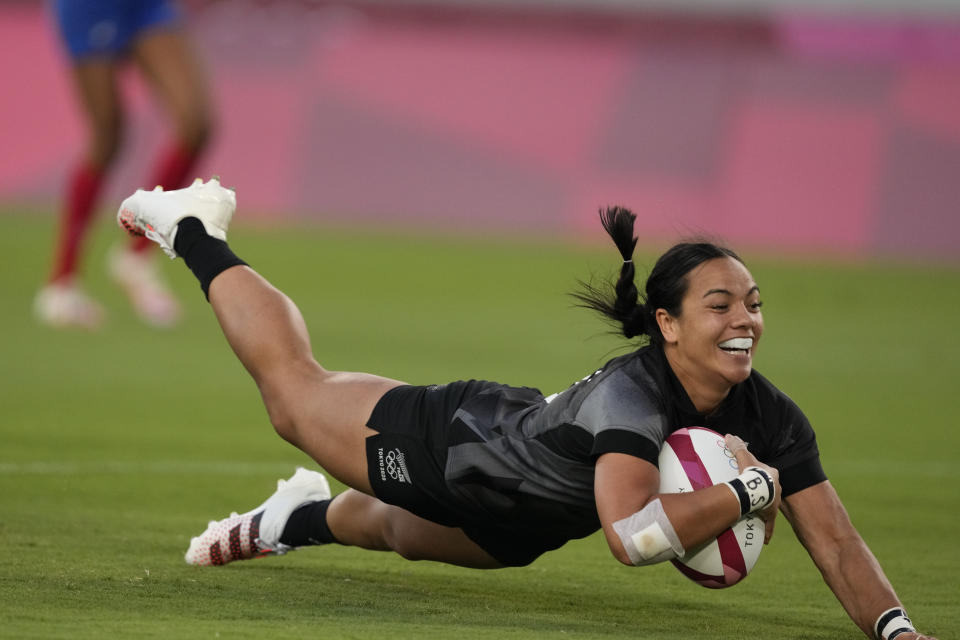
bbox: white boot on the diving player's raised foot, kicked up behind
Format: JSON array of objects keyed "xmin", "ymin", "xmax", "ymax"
[{"xmin": 117, "ymin": 176, "xmax": 237, "ymax": 259}]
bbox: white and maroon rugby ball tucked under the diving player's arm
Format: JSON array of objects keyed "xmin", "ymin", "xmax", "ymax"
[{"xmin": 660, "ymin": 427, "xmax": 764, "ymax": 589}]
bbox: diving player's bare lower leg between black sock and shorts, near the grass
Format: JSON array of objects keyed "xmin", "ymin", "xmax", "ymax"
[{"xmin": 327, "ymin": 490, "xmax": 503, "ymax": 569}]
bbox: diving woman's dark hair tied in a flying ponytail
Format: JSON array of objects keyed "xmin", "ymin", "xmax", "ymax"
[{"xmin": 573, "ymin": 207, "xmax": 743, "ymax": 344}]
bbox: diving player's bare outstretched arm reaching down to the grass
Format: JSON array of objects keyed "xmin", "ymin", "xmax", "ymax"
[{"xmin": 781, "ymin": 481, "xmax": 933, "ymax": 640}]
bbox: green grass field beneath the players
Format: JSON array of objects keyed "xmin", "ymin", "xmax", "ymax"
[{"xmin": 0, "ymin": 212, "xmax": 960, "ymax": 640}]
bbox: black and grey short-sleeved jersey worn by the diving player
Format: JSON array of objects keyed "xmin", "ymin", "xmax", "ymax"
[{"xmin": 444, "ymin": 346, "xmax": 826, "ymax": 538}]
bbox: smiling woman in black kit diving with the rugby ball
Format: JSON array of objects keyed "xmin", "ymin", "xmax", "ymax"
[{"xmin": 118, "ymin": 179, "xmax": 926, "ymax": 640}]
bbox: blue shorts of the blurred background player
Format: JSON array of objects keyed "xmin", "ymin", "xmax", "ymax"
[{"xmin": 51, "ymin": 0, "xmax": 182, "ymax": 60}]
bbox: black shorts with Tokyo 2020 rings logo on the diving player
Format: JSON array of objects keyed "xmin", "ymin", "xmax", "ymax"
[{"xmin": 367, "ymin": 380, "xmax": 568, "ymax": 566}]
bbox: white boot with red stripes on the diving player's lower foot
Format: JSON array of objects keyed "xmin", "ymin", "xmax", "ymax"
[{"xmin": 184, "ymin": 467, "xmax": 330, "ymax": 566}]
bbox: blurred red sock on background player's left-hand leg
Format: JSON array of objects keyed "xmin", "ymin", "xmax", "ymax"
[{"xmin": 50, "ymin": 160, "xmax": 104, "ymax": 282}]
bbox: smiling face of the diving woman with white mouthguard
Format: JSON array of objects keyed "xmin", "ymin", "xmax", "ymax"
[{"xmin": 656, "ymin": 258, "xmax": 763, "ymax": 413}]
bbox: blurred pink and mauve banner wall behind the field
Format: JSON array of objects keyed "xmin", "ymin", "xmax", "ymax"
[{"xmin": 0, "ymin": 0, "xmax": 960, "ymax": 259}]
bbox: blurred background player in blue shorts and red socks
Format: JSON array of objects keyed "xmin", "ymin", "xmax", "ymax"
[{"xmin": 34, "ymin": 0, "xmax": 211, "ymax": 329}]
